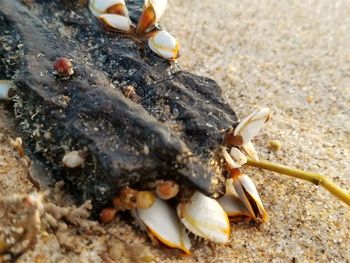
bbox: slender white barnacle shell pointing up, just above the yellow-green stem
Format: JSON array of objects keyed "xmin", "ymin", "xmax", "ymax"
[{"xmin": 234, "ymin": 108, "xmax": 270, "ymax": 144}]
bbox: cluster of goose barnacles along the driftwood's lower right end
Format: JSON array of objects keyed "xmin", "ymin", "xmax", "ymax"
[{"xmin": 100, "ymin": 108, "xmax": 270, "ymax": 254}]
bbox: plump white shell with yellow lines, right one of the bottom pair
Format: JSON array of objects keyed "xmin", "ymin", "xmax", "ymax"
[{"xmin": 177, "ymin": 191, "xmax": 230, "ymax": 243}]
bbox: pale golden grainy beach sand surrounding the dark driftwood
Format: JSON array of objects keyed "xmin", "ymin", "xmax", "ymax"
[{"xmin": 0, "ymin": 0, "xmax": 350, "ymax": 262}]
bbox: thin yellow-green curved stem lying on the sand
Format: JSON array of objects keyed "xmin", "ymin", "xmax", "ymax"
[{"xmin": 246, "ymin": 159, "xmax": 350, "ymax": 206}]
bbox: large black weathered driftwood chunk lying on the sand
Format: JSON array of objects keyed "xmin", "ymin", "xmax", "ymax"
[{"xmin": 0, "ymin": 0, "xmax": 237, "ymax": 211}]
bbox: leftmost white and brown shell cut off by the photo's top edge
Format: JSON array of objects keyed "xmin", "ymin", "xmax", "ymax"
[{"xmin": 89, "ymin": 0, "xmax": 129, "ymax": 17}]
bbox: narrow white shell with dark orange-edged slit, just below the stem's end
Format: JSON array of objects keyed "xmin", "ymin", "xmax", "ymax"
[{"xmin": 232, "ymin": 174, "xmax": 267, "ymax": 221}]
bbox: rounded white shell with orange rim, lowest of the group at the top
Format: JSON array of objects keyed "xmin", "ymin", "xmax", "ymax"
[{"xmin": 148, "ymin": 30, "xmax": 180, "ymax": 60}]
